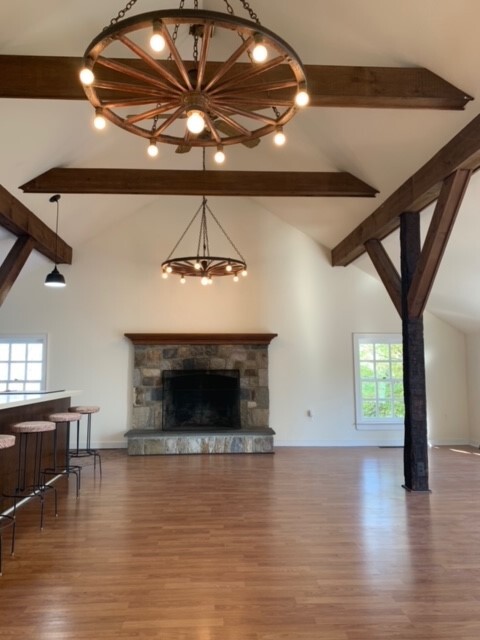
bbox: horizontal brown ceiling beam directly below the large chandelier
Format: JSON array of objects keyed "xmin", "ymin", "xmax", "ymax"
[{"xmin": 20, "ymin": 168, "xmax": 377, "ymax": 197}]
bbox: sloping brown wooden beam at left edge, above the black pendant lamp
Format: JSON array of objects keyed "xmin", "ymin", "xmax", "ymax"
[{"xmin": 0, "ymin": 185, "xmax": 72, "ymax": 264}]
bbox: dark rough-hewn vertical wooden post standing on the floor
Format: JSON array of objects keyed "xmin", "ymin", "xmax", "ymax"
[{"xmin": 400, "ymin": 213, "xmax": 429, "ymax": 491}]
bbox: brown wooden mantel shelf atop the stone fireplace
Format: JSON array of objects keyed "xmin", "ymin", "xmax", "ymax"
[{"xmin": 124, "ymin": 333, "xmax": 278, "ymax": 346}]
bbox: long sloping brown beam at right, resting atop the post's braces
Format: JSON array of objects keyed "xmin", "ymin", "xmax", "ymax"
[{"xmin": 332, "ymin": 116, "xmax": 480, "ymax": 267}]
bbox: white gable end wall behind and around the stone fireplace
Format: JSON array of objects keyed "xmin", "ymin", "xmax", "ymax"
[{"xmin": 0, "ymin": 197, "xmax": 468, "ymax": 447}]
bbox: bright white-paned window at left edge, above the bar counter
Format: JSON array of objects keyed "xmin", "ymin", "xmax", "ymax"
[{"xmin": 0, "ymin": 335, "xmax": 47, "ymax": 392}]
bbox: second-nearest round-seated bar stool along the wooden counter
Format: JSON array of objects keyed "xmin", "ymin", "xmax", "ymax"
[{"xmin": 9, "ymin": 420, "xmax": 58, "ymax": 529}]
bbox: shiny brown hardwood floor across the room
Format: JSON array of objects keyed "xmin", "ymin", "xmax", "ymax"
[{"xmin": 0, "ymin": 447, "xmax": 480, "ymax": 640}]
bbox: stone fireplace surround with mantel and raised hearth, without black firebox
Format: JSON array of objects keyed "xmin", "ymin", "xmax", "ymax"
[{"xmin": 125, "ymin": 334, "xmax": 276, "ymax": 455}]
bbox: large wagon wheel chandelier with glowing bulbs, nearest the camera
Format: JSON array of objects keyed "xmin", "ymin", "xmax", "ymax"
[{"xmin": 80, "ymin": 0, "xmax": 309, "ymax": 163}]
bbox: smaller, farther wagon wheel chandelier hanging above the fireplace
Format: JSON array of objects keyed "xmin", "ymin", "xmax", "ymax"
[{"xmin": 162, "ymin": 147, "xmax": 247, "ymax": 285}]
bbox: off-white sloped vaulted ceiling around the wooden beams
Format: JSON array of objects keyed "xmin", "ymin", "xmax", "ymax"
[{"xmin": 0, "ymin": 0, "xmax": 480, "ymax": 331}]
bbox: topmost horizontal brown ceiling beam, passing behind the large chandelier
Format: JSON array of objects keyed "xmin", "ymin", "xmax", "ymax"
[{"xmin": 0, "ymin": 55, "xmax": 472, "ymax": 109}]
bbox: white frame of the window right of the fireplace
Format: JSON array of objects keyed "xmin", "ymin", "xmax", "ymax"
[{"xmin": 353, "ymin": 333, "xmax": 405, "ymax": 431}]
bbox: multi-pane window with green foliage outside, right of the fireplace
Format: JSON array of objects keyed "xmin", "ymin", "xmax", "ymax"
[{"xmin": 354, "ymin": 333, "xmax": 405, "ymax": 429}]
